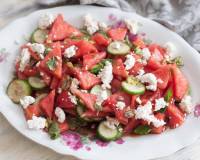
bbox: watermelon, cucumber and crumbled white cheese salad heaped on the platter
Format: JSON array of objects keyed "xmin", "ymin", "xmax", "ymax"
[{"xmin": 7, "ymin": 13, "xmax": 193, "ymax": 141}]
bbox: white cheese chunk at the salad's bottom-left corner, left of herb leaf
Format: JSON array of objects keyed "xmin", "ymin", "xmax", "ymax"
[{"xmin": 27, "ymin": 116, "xmax": 46, "ymax": 130}]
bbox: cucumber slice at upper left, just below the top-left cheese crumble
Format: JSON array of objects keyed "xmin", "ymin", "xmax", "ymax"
[{"xmin": 31, "ymin": 29, "xmax": 48, "ymax": 43}]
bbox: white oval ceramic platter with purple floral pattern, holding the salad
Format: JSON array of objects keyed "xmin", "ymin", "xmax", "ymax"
[{"xmin": 0, "ymin": 6, "xmax": 200, "ymax": 160}]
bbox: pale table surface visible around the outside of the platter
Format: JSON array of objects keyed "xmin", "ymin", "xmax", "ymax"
[{"xmin": 0, "ymin": 0, "xmax": 200, "ymax": 160}]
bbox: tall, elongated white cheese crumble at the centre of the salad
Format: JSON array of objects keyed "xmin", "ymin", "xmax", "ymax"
[{"xmin": 98, "ymin": 61, "xmax": 113, "ymax": 89}]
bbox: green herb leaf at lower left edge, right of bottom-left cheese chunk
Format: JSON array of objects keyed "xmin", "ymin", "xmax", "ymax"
[{"xmin": 48, "ymin": 121, "xmax": 60, "ymax": 140}]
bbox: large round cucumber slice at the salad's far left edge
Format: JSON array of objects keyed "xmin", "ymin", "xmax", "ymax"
[{"xmin": 7, "ymin": 79, "xmax": 32, "ymax": 103}]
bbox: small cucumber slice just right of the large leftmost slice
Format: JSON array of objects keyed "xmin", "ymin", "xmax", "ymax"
[{"xmin": 28, "ymin": 77, "xmax": 46, "ymax": 89}]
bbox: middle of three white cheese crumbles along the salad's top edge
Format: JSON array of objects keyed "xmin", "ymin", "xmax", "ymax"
[{"xmin": 84, "ymin": 14, "xmax": 99, "ymax": 35}]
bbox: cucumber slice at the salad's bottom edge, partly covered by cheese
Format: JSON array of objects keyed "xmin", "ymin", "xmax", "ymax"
[{"xmin": 97, "ymin": 121, "xmax": 119, "ymax": 141}]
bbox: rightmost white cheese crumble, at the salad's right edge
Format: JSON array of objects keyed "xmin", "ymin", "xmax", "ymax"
[{"xmin": 179, "ymin": 95, "xmax": 193, "ymax": 113}]
